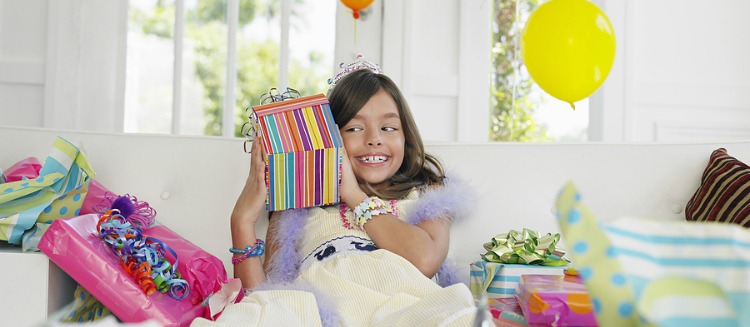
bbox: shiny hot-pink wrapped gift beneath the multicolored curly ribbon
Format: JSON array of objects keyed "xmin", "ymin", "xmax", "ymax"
[{"xmin": 39, "ymin": 214, "xmax": 227, "ymax": 326}]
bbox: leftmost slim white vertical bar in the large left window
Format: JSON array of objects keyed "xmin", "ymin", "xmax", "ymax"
[{"xmin": 172, "ymin": 0, "xmax": 185, "ymax": 134}]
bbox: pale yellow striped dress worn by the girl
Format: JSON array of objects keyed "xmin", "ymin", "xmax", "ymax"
[{"xmin": 191, "ymin": 187, "xmax": 476, "ymax": 326}]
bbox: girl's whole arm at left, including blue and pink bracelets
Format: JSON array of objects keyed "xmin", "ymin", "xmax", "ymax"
[{"xmin": 230, "ymin": 138, "xmax": 271, "ymax": 288}]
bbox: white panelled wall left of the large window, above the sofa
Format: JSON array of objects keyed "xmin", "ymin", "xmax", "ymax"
[{"xmin": 0, "ymin": 0, "xmax": 127, "ymax": 131}]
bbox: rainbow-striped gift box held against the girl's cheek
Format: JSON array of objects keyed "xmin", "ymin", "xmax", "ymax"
[{"xmin": 253, "ymin": 94, "xmax": 344, "ymax": 211}]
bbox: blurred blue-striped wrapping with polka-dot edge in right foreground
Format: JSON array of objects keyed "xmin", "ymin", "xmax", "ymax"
[{"xmin": 557, "ymin": 183, "xmax": 750, "ymax": 326}]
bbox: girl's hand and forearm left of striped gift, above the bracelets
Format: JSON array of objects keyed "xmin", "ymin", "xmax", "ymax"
[{"xmin": 232, "ymin": 137, "xmax": 267, "ymax": 224}]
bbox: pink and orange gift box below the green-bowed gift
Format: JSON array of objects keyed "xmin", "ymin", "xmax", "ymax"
[{"xmin": 516, "ymin": 275, "xmax": 597, "ymax": 327}]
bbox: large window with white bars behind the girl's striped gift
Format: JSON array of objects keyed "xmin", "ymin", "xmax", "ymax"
[{"xmin": 124, "ymin": 0, "xmax": 336, "ymax": 136}]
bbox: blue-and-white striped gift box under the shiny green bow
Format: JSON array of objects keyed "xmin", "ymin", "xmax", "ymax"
[{"xmin": 469, "ymin": 260, "xmax": 566, "ymax": 299}]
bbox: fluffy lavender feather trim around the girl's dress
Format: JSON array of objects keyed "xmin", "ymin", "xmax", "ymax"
[{"xmin": 267, "ymin": 177, "xmax": 474, "ymax": 287}]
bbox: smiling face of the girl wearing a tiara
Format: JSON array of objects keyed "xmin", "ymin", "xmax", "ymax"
[{"xmin": 341, "ymin": 89, "xmax": 405, "ymax": 186}]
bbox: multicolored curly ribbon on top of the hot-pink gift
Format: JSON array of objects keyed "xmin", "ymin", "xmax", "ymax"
[{"xmin": 96, "ymin": 209, "xmax": 190, "ymax": 300}]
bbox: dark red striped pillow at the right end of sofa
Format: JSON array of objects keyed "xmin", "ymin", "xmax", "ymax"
[{"xmin": 685, "ymin": 148, "xmax": 750, "ymax": 227}]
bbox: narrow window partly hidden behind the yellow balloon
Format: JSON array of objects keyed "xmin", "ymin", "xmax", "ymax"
[{"xmin": 490, "ymin": 0, "xmax": 589, "ymax": 142}]
